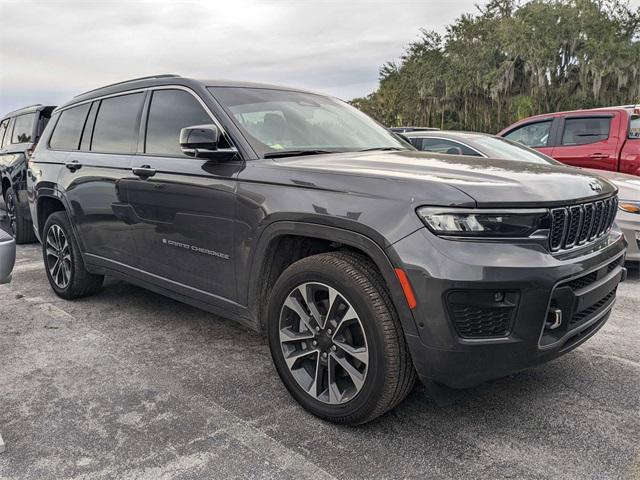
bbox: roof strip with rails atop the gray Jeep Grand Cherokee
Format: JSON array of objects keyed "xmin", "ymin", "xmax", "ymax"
[{"xmin": 60, "ymin": 73, "xmax": 324, "ymax": 108}]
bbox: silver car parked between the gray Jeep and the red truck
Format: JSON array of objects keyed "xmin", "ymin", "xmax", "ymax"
[{"xmin": 405, "ymin": 131, "xmax": 640, "ymax": 261}]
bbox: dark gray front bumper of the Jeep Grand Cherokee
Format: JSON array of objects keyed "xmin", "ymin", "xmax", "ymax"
[{"xmin": 389, "ymin": 229, "xmax": 626, "ymax": 388}]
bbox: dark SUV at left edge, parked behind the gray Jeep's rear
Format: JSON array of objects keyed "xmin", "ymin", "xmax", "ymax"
[{"xmin": 0, "ymin": 105, "xmax": 55, "ymax": 243}]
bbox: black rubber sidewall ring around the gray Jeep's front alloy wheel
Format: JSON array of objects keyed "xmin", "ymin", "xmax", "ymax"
[{"xmin": 267, "ymin": 262, "xmax": 387, "ymax": 423}]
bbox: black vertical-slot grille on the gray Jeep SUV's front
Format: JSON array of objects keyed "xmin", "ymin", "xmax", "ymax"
[{"xmin": 549, "ymin": 197, "xmax": 618, "ymax": 252}]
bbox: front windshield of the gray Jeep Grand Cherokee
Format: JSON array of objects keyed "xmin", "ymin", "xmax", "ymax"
[{"xmin": 209, "ymin": 87, "xmax": 411, "ymax": 156}]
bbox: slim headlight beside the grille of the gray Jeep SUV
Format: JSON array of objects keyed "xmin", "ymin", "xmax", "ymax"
[{"xmin": 417, "ymin": 207, "xmax": 550, "ymax": 238}]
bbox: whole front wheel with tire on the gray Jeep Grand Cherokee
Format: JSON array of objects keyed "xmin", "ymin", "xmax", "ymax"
[{"xmin": 267, "ymin": 252, "xmax": 416, "ymax": 425}]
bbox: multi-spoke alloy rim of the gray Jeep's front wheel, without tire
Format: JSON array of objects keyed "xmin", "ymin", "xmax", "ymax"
[{"xmin": 278, "ymin": 282, "xmax": 369, "ymax": 405}]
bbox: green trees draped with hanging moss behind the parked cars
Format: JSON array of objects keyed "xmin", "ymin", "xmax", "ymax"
[{"xmin": 351, "ymin": 0, "xmax": 640, "ymax": 132}]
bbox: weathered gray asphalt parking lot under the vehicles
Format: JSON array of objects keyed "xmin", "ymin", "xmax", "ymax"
[{"xmin": 0, "ymin": 208, "xmax": 640, "ymax": 480}]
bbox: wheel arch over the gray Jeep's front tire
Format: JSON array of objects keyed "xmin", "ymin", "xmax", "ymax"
[{"xmin": 247, "ymin": 221, "xmax": 417, "ymax": 334}]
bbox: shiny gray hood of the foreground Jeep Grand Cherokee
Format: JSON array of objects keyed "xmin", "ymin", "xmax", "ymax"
[{"xmin": 276, "ymin": 151, "xmax": 616, "ymax": 207}]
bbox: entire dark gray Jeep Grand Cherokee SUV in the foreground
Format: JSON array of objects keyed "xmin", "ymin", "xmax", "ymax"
[{"xmin": 29, "ymin": 75, "xmax": 626, "ymax": 424}]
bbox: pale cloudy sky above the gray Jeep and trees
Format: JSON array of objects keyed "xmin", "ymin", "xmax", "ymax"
[{"xmin": 0, "ymin": 0, "xmax": 492, "ymax": 112}]
